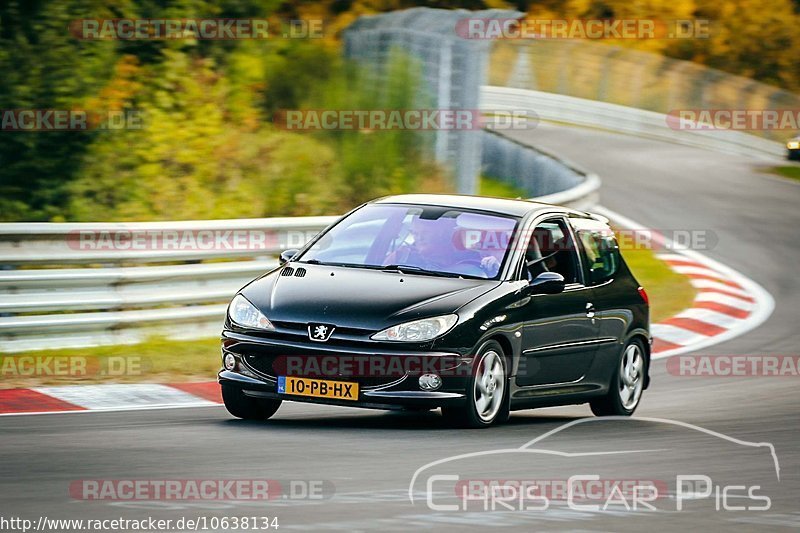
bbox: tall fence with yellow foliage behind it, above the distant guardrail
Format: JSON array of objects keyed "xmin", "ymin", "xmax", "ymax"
[{"xmin": 485, "ymin": 39, "xmax": 800, "ymax": 143}]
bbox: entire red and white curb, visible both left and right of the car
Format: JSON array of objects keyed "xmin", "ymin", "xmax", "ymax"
[{"xmin": 0, "ymin": 207, "xmax": 775, "ymax": 416}]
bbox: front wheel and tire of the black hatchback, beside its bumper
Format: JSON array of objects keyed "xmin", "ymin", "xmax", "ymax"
[{"xmin": 442, "ymin": 341, "xmax": 509, "ymax": 428}]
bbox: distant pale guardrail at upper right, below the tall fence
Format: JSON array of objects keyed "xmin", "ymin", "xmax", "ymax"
[{"xmin": 481, "ymin": 86, "xmax": 785, "ymax": 160}]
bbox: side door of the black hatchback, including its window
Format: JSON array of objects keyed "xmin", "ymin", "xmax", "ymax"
[{"xmin": 517, "ymin": 216, "xmax": 598, "ymax": 386}]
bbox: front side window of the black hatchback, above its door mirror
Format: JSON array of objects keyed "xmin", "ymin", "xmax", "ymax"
[{"xmin": 523, "ymin": 219, "xmax": 580, "ymax": 284}]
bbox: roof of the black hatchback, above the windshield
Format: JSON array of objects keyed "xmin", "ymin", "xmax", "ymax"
[{"xmin": 370, "ymin": 194, "xmax": 586, "ymax": 217}]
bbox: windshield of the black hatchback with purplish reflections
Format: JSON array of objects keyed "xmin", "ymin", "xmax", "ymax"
[{"xmin": 298, "ymin": 204, "xmax": 518, "ymax": 279}]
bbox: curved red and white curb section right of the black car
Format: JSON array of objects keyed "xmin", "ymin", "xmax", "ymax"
[{"xmin": 594, "ymin": 207, "xmax": 775, "ymax": 359}]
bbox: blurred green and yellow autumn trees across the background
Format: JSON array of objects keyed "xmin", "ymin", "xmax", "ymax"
[{"xmin": 0, "ymin": 0, "xmax": 800, "ymax": 221}]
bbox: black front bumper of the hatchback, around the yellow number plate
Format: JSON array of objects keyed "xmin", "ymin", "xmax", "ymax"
[{"xmin": 218, "ymin": 330, "xmax": 472, "ymax": 409}]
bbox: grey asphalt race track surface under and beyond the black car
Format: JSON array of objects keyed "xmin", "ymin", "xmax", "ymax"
[{"xmin": 0, "ymin": 125, "xmax": 800, "ymax": 531}]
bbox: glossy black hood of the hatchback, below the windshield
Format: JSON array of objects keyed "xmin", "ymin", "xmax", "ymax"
[{"xmin": 242, "ymin": 263, "xmax": 499, "ymax": 330}]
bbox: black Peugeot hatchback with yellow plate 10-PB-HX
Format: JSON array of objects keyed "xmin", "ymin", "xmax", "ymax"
[{"xmin": 219, "ymin": 195, "xmax": 651, "ymax": 427}]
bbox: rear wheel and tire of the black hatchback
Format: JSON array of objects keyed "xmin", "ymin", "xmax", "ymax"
[{"xmin": 589, "ymin": 339, "xmax": 647, "ymax": 416}]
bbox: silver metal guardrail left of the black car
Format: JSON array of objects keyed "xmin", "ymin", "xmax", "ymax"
[{"xmin": 0, "ymin": 216, "xmax": 338, "ymax": 352}]
